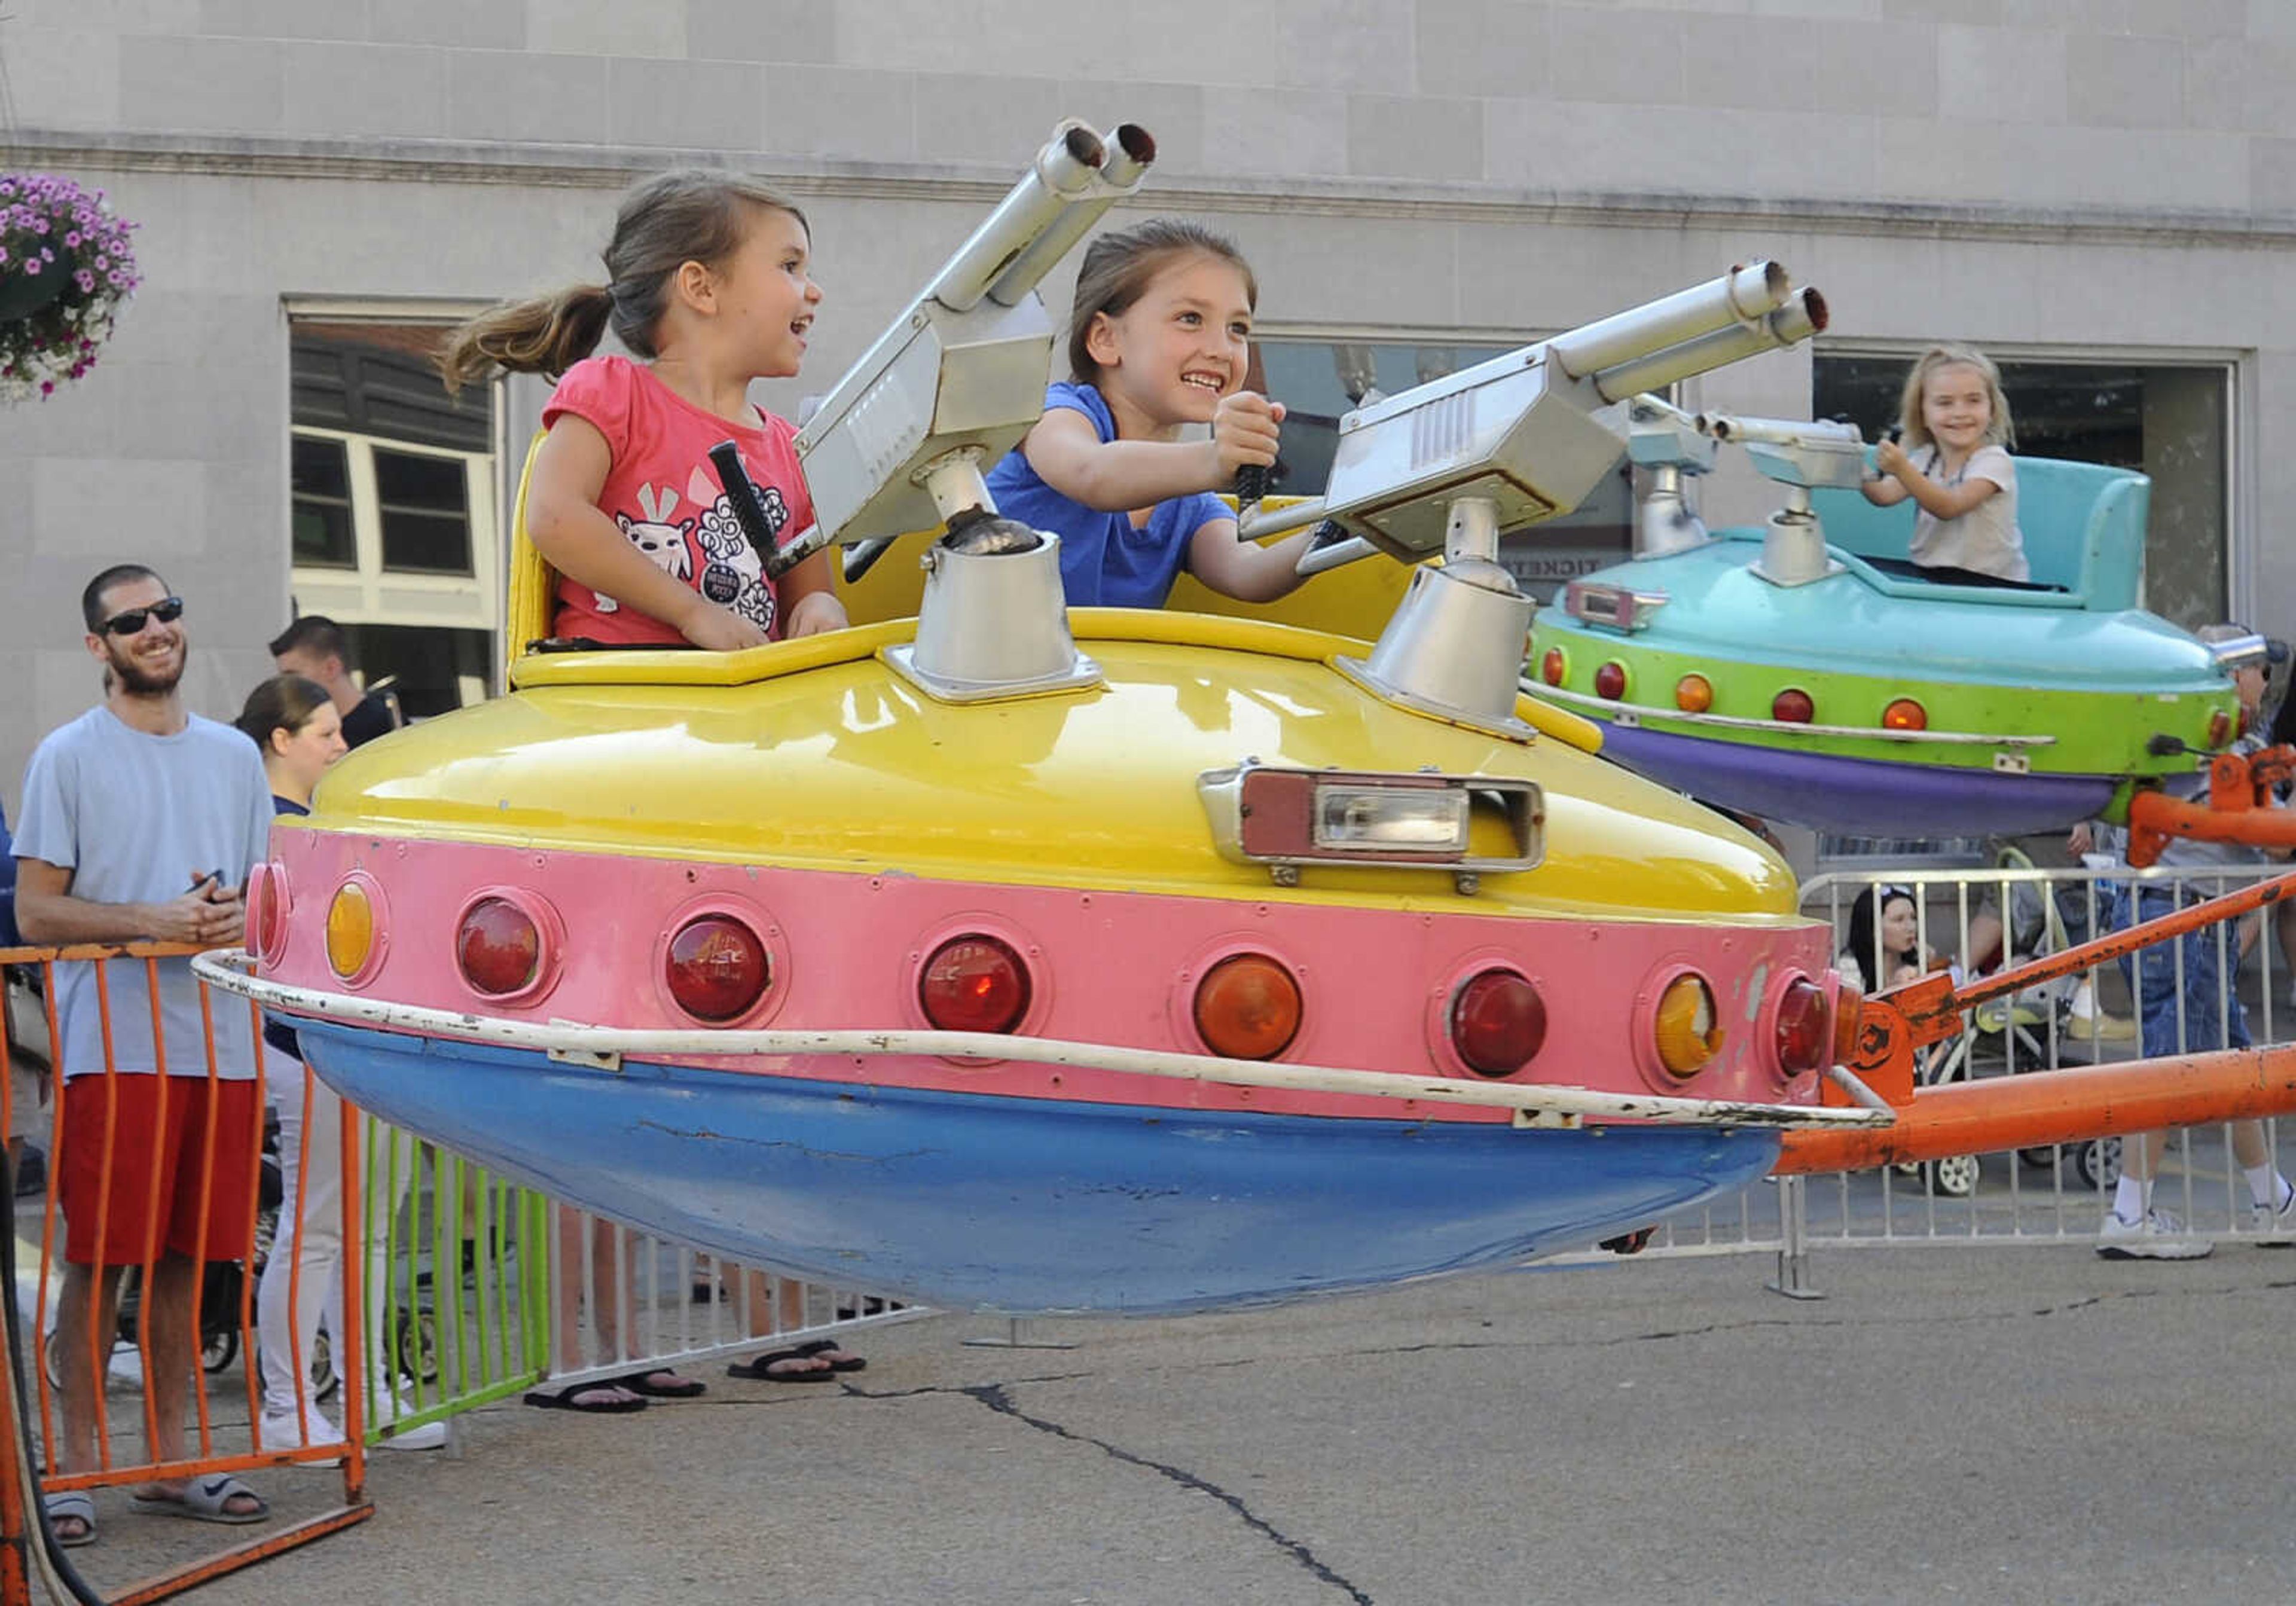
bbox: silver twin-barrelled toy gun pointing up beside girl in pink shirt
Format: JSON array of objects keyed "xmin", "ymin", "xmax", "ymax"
[{"xmin": 769, "ymin": 120, "xmax": 1155, "ymax": 575}]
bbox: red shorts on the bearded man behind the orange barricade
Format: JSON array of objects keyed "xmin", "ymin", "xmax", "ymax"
[{"xmin": 55, "ymin": 1073, "xmax": 262, "ymax": 1266}]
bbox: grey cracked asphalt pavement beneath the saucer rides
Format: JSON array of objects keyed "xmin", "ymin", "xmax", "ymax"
[{"xmin": 49, "ymin": 1245, "xmax": 2296, "ymax": 1606}]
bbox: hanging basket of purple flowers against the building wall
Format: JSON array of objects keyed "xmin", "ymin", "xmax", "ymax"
[{"xmin": 0, "ymin": 172, "xmax": 142, "ymax": 402}]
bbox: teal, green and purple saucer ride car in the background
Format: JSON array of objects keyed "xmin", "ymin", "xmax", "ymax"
[{"xmin": 1527, "ymin": 408, "xmax": 2264, "ymax": 836}]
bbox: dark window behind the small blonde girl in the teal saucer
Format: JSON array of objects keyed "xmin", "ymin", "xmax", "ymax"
[{"xmin": 1812, "ymin": 352, "xmax": 2231, "ymax": 630}]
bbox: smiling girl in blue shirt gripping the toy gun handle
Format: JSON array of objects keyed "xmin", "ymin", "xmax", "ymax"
[{"xmin": 990, "ymin": 218, "xmax": 1309, "ymax": 609}]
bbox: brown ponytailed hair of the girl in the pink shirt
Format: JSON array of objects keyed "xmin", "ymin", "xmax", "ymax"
[{"xmin": 436, "ymin": 168, "xmax": 813, "ymax": 390}]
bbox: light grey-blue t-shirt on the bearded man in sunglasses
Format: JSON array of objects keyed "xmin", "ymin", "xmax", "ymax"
[{"xmin": 14, "ymin": 706, "xmax": 271, "ymax": 1080}]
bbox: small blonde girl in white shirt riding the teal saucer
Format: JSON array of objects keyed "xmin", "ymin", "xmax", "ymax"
[{"xmin": 1864, "ymin": 344, "xmax": 2032, "ymax": 581}]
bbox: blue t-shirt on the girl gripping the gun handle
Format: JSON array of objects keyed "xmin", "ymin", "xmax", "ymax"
[{"xmin": 990, "ymin": 384, "xmax": 1235, "ymax": 609}]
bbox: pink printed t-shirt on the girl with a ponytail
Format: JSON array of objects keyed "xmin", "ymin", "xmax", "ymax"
[{"xmin": 542, "ymin": 356, "xmax": 813, "ymax": 643}]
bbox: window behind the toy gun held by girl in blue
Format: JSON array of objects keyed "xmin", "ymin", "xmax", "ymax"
[{"xmin": 1251, "ymin": 338, "xmax": 1635, "ymax": 602}]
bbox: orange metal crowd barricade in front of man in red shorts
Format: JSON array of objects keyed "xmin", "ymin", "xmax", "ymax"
[{"xmin": 0, "ymin": 944, "xmax": 374, "ymax": 1606}]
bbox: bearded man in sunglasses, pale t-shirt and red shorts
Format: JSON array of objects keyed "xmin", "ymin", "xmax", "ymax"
[{"xmin": 11, "ymin": 563, "xmax": 271, "ymax": 1544}]
